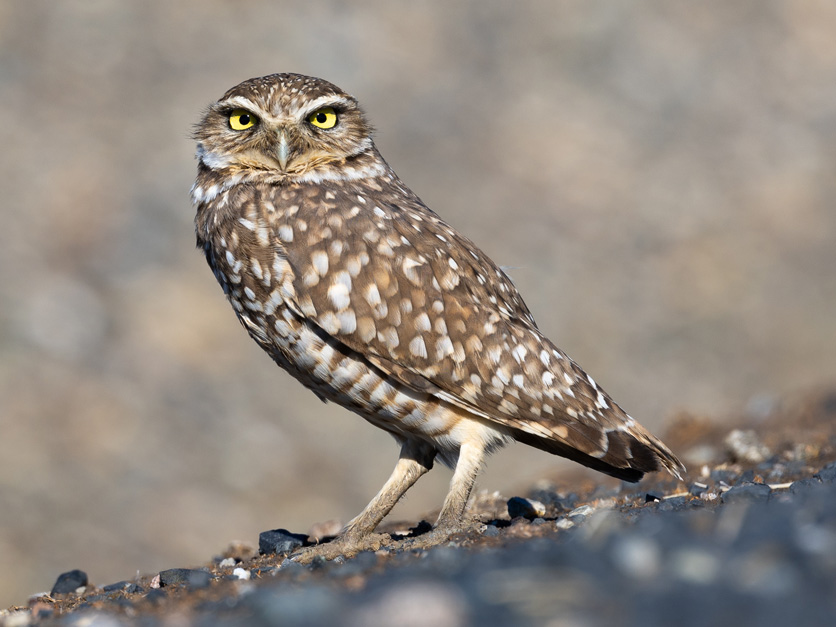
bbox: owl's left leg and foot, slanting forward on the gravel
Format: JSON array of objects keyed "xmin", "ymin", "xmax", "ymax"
[{"xmin": 292, "ymin": 440, "xmax": 436, "ymax": 564}]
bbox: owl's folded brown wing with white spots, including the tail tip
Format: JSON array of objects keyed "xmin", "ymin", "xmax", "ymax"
[{"xmin": 278, "ymin": 186, "xmax": 681, "ymax": 480}]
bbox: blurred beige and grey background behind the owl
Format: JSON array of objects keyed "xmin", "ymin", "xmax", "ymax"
[{"xmin": 0, "ymin": 0, "xmax": 836, "ymax": 607}]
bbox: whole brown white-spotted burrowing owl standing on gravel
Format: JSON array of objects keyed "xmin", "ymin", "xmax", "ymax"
[{"xmin": 192, "ymin": 74, "xmax": 683, "ymax": 557}]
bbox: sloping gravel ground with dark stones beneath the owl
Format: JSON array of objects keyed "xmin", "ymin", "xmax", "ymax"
[{"xmin": 0, "ymin": 391, "xmax": 836, "ymax": 627}]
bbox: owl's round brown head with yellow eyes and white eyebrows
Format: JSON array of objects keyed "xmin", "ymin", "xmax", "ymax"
[{"xmin": 194, "ymin": 74, "xmax": 385, "ymax": 182}]
